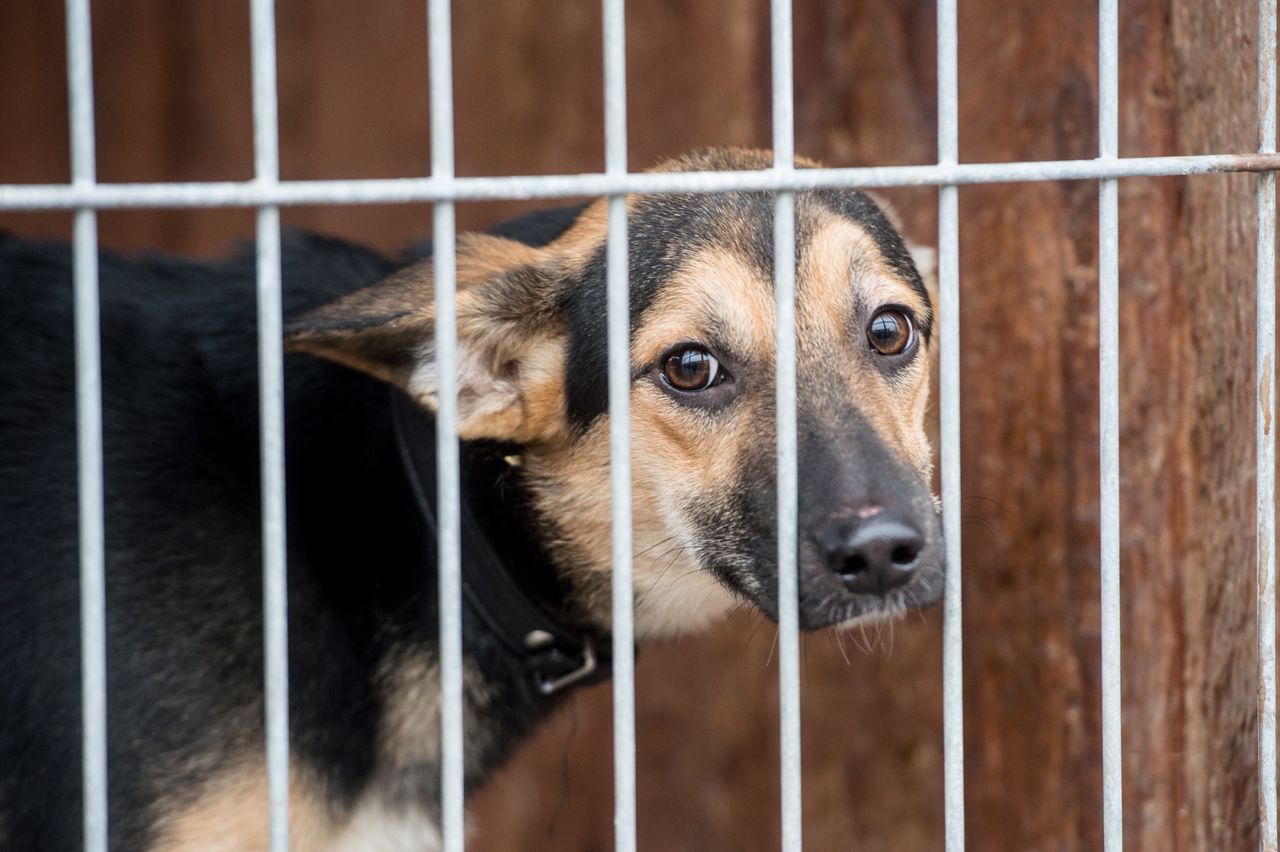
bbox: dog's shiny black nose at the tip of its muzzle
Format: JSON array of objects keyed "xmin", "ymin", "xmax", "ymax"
[{"xmin": 818, "ymin": 510, "xmax": 924, "ymax": 595}]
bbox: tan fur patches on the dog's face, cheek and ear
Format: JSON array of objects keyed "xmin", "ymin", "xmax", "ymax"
[{"xmin": 292, "ymin": 152, "xmax": 947, "ymax": 638}]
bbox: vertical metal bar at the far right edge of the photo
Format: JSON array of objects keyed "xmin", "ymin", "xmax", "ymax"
[{"xmin": 1256, "ymin": 0, "xmax": 1280, "ymax": 852}]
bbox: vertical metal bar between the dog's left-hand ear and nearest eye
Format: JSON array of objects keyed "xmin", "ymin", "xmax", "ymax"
[{"xmin": 603, "ymin": 0, "xmax": 636, "ymax": 852}]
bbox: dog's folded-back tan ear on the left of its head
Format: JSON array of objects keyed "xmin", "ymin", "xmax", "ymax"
[{"xmin": 293, "ymin": 234, "xmax": 564, "ymax": 444}]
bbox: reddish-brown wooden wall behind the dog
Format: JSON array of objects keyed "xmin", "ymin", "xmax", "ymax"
[{"xmin": 0, "ymin": 0, "xmax": 1257, "ymax": 852}]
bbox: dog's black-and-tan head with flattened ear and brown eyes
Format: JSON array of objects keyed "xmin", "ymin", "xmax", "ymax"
[{"xmin": 289, "ymin": 150, "xmax": 943, "ymax": 635}]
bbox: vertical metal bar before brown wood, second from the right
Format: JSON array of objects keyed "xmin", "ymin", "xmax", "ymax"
[{"xmin": 1098, "ymin": 0, "xmax": 1124, "ymax": 852}]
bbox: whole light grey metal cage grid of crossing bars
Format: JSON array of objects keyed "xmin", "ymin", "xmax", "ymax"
[{"xmin": 0, "ymin": 0, "xmax": 1280, "ymax": 852}]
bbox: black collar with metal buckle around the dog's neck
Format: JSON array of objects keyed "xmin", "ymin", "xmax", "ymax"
[{"xmin": 390, "ymin": 389, "xmax": 612, "ymax": 696}]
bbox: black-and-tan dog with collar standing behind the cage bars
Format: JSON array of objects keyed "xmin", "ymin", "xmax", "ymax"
[{"xmin": 0, "ymin": 150, "xmax": 943, "ymax": 852}]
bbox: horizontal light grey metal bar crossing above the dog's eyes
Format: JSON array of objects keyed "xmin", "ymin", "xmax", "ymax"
[{"xmin": 0, "ymin": 154, "xmax": 1280, "ymax": 210}]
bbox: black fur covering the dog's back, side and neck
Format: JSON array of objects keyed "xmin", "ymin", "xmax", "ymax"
[{"xmin": 0, "ymin": 207, "xmax": 580, "ymax": 849}]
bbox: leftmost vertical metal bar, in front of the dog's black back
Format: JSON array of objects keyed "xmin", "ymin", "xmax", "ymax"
[{"xmin": 67, "ymin": 0, "xmax": 108, "ymax": 852}]
